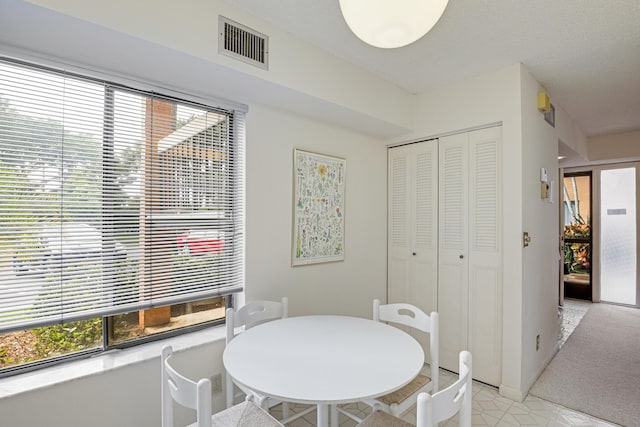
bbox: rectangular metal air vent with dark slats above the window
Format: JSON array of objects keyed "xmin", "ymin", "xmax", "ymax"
[{"xmin": 218, "ymin": 16, "xmax": 269, "ymax": 70}]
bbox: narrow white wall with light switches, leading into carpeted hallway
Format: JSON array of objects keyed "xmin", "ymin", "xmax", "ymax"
[{"xmin": 521, "ymin": 68, "xmax": 560, "ymax": 390}]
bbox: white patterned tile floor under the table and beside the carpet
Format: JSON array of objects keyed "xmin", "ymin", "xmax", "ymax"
[{"xmin": 274, "ymin": 300, "xmax": 616, "ymax": 427}]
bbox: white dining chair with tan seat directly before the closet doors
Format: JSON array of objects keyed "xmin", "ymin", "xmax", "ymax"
[{"xmin": 348, "ymin": 299, "xmax": 439, "ymax": 421}]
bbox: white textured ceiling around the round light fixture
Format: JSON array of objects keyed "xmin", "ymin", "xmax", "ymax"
[{"xmin": 228, "ymin": 0, "xmax": 640, "ymax": 136}]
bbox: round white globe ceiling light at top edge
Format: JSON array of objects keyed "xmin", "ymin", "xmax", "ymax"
[{"xmin": 339, "ymin": 0, "xmax": 449, "ymax": 49}]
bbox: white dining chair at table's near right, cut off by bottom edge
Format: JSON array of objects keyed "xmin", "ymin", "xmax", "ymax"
[{"xmin": 358, "ymin": 351, "xmax": 472, "ymax": 427}]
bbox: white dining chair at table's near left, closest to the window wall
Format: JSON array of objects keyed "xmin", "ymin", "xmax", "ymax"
[{"xmin": 160, "ymin": 346, "xmax": 283, "ymax": 427}]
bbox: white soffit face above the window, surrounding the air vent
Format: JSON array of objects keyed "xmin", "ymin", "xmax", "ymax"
[{"xmin": 18, "ymin": 0, "xmax": 413, "ymax": 134}]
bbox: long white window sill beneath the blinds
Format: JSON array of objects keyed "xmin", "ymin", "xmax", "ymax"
[{"xmin": 0, "ymin": 326, "xmax": 226, "ymax": 399}]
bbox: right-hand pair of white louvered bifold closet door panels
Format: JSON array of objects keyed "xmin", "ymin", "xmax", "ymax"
[{"xmin": 438, "ymin": 127, "xmax": 502, "ymax": 385}]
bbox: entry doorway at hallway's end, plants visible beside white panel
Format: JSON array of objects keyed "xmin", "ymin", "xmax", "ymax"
[{"xmin": 560, "ymin": 162, "xmax": 640, "ymax": 307}]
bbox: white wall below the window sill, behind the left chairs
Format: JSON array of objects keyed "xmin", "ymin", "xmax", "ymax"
[{"xmin": 0, "ymin": 333, "xmax": 229, "ymax": 427}]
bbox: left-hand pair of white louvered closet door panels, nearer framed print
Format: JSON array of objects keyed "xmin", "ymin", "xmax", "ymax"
[{"xmin": 388, "ymin": 140, "xmax": 438, "ymax": 354}]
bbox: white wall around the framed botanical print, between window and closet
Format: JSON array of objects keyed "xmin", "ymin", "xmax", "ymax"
[{"xmin": 246, "ymin": 105, "xmax": 387, "ymax": 317}]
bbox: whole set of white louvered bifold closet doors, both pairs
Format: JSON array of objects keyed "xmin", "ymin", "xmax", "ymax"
[{"xmin": 388, "ymin": 127, "xmax": 502, "ymax": 385}]
